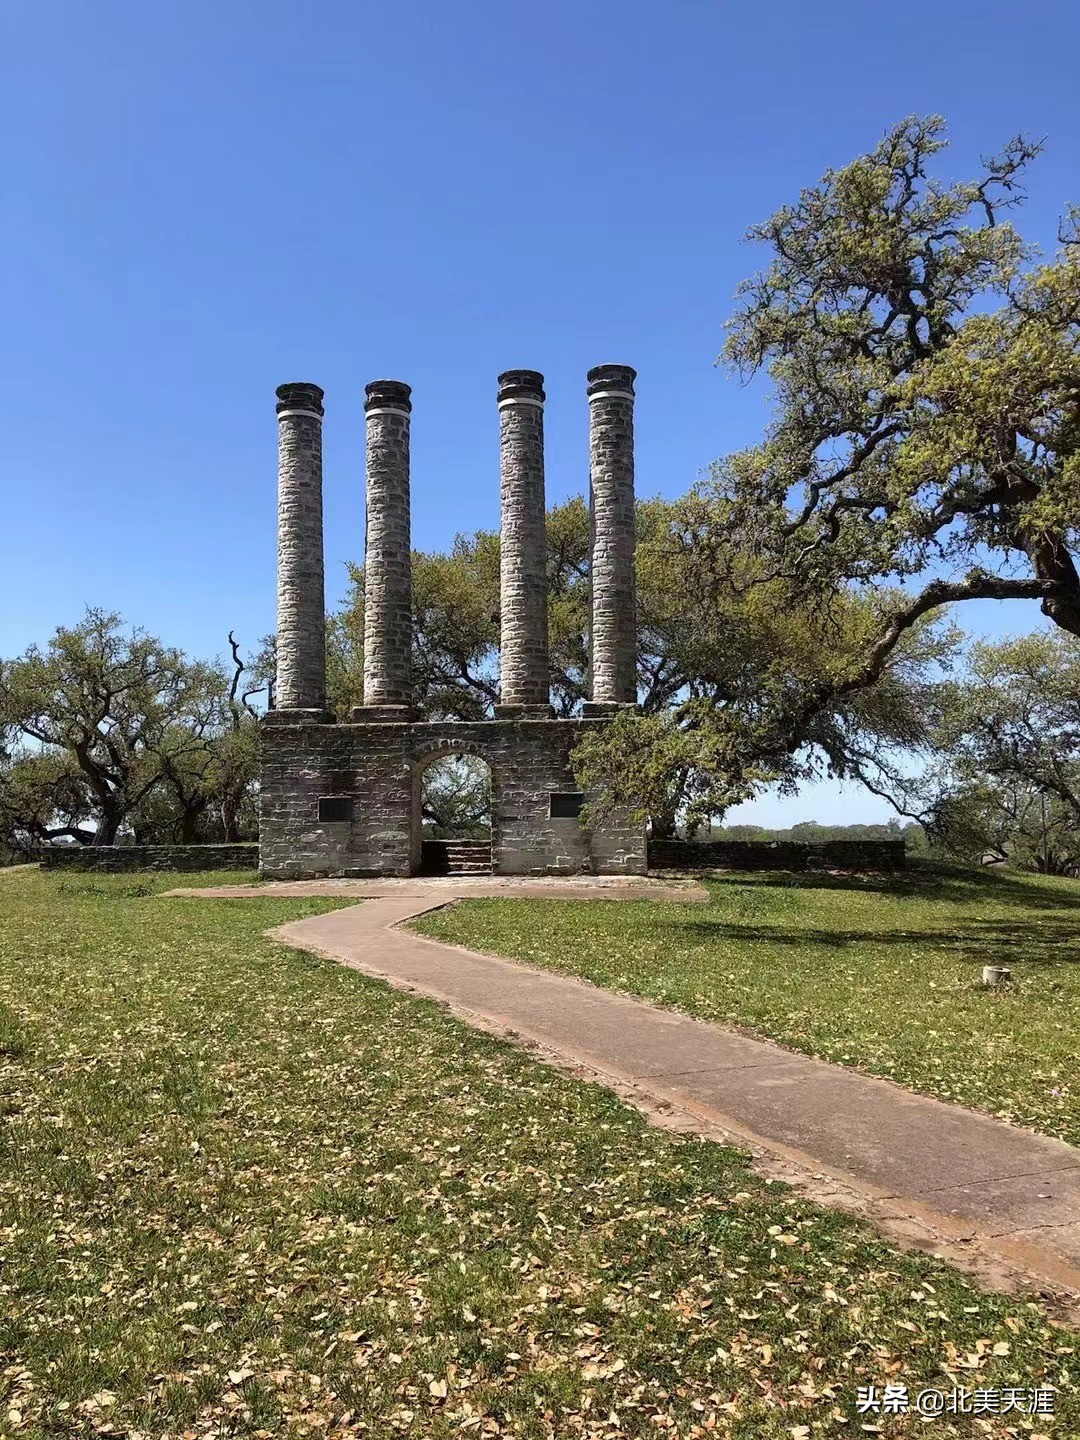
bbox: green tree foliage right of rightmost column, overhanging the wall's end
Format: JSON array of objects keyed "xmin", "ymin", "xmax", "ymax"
[{"xmin": 575, "ymin": 561, "xmax": 959, "ymax": 835}]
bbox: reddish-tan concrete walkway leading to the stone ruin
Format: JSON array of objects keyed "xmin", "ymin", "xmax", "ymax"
[{"xmin": 171, "ymin": 878, "xmax": 1080, "ymax": 1293}]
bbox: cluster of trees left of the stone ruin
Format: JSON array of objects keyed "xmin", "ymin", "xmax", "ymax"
[{"xmin": 0, "ymin": 609, "xmax": 258, "ymax": 848}]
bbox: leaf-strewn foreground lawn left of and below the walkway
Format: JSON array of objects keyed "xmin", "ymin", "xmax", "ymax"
[{"xmin": 0, "ymin": 873, "xmax": 1080, "ymax": 1440}]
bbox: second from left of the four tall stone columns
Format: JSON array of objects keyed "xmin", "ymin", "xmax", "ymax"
[{"xmin": 356, "ymin": 380, "xmax": 415, "ymax": 720}]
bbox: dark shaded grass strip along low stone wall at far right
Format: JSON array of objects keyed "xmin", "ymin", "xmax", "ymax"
[{"xmin": 711, "ymin": 861, "xmax": 1080, "ymax": 910}]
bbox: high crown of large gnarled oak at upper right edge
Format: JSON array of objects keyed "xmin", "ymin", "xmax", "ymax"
[{"xmin": 707, "ymin": 118, "xmax": 1080, "ymax": 639}]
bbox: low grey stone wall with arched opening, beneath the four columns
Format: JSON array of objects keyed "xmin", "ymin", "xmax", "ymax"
[{"xmin": 259, "ymin": 720, "xmax": 645, "ymax": 880}]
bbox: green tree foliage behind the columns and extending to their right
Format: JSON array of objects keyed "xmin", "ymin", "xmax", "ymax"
[{"xmin": 328, "ymin": 497, "xmax": 955, "ymax": 834}]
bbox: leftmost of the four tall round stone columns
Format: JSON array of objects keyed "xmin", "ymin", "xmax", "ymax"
[{"xmin": 268, "ymin": 380, "xmax": 333, "ymax": 724}]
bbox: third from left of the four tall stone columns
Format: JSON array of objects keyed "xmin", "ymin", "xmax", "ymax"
[{"xmin": 495, "ymin": 370, "xmax": 553, "ymax": 719}]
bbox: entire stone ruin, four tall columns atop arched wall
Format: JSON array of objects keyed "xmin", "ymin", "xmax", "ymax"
[{"xmin": 259, "ymin": 366, "xmax": 645, "ymax": 878}]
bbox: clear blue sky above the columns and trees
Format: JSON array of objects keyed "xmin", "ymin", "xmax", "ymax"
[{"xmin": 0, "ymin": 0, "xmax": 1080, "ymax": 822}]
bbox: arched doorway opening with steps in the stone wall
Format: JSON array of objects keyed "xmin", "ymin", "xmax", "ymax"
[{"xmin": 412, "ymin": 750, "xmax": 492, "ymax": 876}]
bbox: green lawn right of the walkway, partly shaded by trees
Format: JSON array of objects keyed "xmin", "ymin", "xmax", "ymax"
[{"xmin": 416, "ymin": 868, "xmax": 1080, "ymax": 1143}]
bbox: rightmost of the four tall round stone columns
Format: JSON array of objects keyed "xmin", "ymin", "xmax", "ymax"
[{"xmin": 585, "ymin": 364, "xmax": 638, "ymax": 716}]
